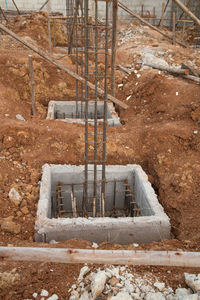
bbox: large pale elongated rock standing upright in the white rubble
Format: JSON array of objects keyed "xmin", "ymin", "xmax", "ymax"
[{"xmin": 91, "ymin": 271, "xmax": 107, "ymax": 299}]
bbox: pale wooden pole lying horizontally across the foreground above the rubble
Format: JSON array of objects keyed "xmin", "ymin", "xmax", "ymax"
[{"xmin": 0, "ymin": 247, "xmax": 200, "ymax": 268}]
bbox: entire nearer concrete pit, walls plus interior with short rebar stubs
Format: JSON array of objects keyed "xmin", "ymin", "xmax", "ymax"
[{"xmin": 35, "ymin": 164, "xmax": 170, "ymax": 244}]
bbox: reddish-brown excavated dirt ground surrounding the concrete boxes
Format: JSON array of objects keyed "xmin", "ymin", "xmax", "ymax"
[{"xmin": 0, "ymin": 14, "xmax": 200, "ymax": 299}]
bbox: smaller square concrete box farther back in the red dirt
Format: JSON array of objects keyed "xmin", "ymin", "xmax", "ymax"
[{"xmin": 47, "ymin": 101, "xmax": 121, "ymax": 126}]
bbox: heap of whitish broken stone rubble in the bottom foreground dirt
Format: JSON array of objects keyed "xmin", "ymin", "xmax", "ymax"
[{"xmin": 69, "ymin": 265, "xmax": 200, "ymax": 300}]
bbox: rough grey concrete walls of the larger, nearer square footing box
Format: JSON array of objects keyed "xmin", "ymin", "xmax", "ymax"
[{"xmin": 35, "ymin": 164, "xmax": 171, "ymax": 244}]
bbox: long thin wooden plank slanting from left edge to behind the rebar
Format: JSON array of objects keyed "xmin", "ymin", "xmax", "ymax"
[{"xmin": 0, "ymin": 24, "xmax": 128, "ymax": 109}]
